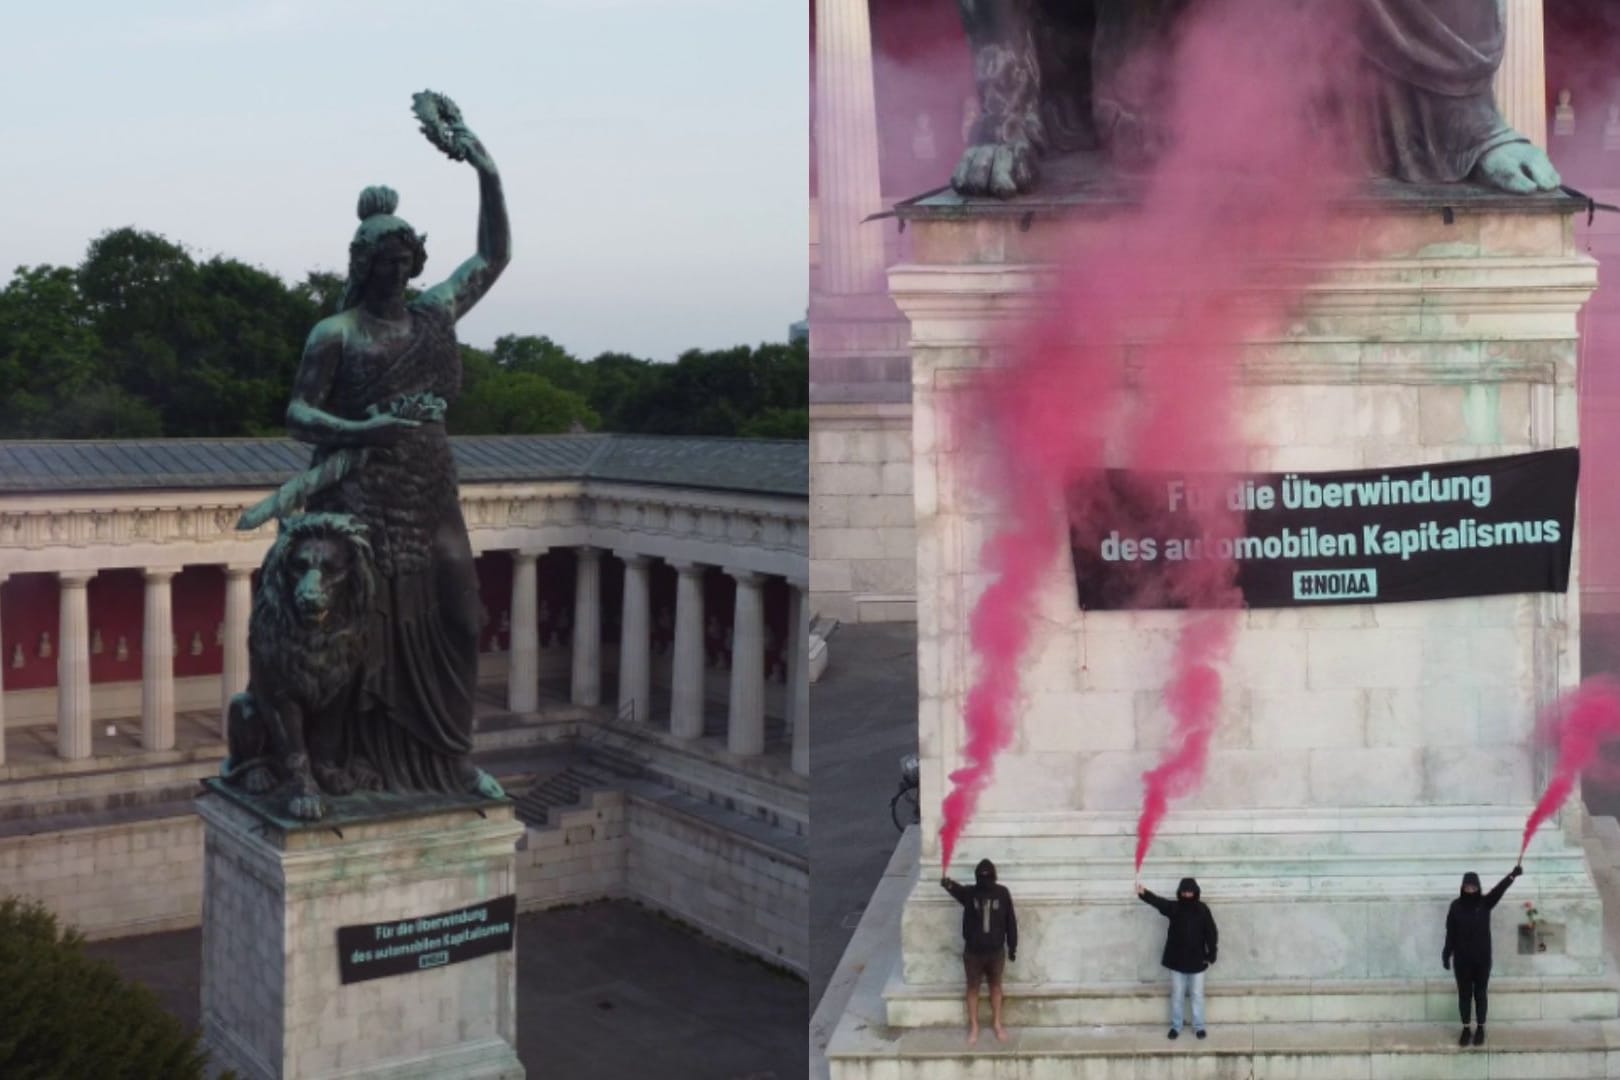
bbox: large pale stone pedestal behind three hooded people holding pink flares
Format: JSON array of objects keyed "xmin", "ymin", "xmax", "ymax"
[{"xmin": 828, "ymin": 185, "xmax": 1620, "ymax": 1080}]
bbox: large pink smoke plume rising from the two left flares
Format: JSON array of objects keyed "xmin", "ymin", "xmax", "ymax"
[{"xmin": 940, "ymin": 0, "xmax": 1351, "ymax": 868}]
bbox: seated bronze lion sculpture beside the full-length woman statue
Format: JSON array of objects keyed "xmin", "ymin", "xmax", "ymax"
[{"xmin": 222, "ymin": 513, "xmax": 381, "ymax": 821}]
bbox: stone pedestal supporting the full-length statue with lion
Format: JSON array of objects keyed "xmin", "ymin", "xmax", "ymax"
[{"xmin": 198, "ymin": 780, "xmax": 523, "ymax": 1080}]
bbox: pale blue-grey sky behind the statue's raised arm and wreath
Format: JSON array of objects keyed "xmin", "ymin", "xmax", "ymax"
[{"xmin": 0, "ymin": 0, "xmax": 808, "ymax": 359}]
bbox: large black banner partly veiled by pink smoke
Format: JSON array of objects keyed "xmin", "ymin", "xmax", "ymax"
[{"xmin": 1071, "ymin": 449, "xmax": 1580, "ymax": 610}]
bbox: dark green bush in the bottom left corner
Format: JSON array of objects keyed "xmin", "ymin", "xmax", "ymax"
[{"xmin": 0, "ymin": 899, "xmax": 215, "ymax": 1080}]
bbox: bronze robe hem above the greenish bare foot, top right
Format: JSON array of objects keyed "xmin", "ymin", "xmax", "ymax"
[{"xmin": 1358, "ymin": 0, "xmax": 1526, "ymax": 183}]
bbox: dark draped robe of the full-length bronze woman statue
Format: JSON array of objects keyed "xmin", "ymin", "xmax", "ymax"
[{"xmin": 309, "ymin": 304, "xmax": 478, "ymax": 792}]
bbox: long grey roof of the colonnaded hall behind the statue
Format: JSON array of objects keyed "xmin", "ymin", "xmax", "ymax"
[{"xmin": 0, "ymin": 434, "xmax": 810, "ymax": 499}]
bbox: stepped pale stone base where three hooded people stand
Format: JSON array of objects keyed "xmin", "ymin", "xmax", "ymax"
[{"xmin": 813, "ymin": 810, "xmax": 1620, "ymax": 1080}]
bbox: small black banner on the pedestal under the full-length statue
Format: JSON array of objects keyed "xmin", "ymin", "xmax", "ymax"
[{"xmin": 337, "ymin": 895, "xmax": 517, "ymax": 984}]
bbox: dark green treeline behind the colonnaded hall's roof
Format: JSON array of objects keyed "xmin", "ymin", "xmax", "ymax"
[{"xmin": 0, "ymin": 228, "xmax": 808, "ymax": 439}]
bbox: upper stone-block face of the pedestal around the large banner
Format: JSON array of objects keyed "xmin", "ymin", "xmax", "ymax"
[{"xmin": 891, "ymin": 212, "xmax": 1594, "ymax": 848}]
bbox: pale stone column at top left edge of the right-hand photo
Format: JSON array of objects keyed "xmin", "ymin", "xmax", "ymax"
[{"xmin": 815, "ymin": 0, "xmax": 883, "ymax": 296}]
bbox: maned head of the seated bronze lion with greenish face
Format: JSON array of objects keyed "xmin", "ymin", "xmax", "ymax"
[{"xmin": 261, "ymin": 513, "xmax": 376, "ymax": 630}]
